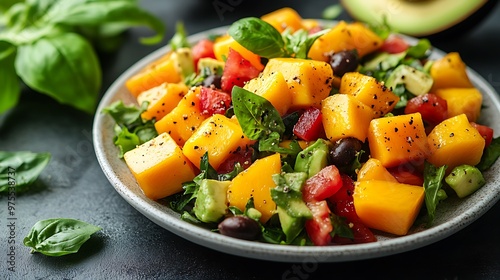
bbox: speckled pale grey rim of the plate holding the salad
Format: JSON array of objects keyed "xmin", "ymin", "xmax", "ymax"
[{"xmin": 92, "ymin": 22, "xmax": 500, "ymax": 262}]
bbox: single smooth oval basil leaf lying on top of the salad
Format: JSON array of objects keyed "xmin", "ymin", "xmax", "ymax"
[{"xmin": 228, "ymin": 17, "xmax": 289, "ymax": 58}]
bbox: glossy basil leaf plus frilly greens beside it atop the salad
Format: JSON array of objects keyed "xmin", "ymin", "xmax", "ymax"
[{"xmin": 228, "ymin": 17, "xmax": 328, "ymax": 59}]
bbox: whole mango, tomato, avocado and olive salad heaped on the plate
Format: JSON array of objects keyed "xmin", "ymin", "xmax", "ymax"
[{"xmin": 104, "ymin": 8, "xmax": 500, "ymax": 246}]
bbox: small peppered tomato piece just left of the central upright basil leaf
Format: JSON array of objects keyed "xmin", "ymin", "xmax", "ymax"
[{"xmin": 200, "ymin": 87, "xmax": 231, "ymax": 116}]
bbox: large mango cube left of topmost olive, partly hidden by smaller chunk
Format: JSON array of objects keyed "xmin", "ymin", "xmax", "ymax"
[{"xmin": 262, "ymin": 58, "xmax": 333, "ymax": 109}]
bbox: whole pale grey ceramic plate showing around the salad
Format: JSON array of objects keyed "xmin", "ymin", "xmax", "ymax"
[{"xmin": 93, "ymin": 24, "xmax": 500, "ymax": 262}]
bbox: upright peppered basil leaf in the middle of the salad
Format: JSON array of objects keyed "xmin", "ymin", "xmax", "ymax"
[{"xmin": 232, "ymin": 86, "xmax": 285, "ymax": 140}]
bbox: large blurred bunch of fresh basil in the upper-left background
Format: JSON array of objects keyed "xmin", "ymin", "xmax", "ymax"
[{"xmin": 0, "ymin": 0, "xmax": 165, "ymax": 113}]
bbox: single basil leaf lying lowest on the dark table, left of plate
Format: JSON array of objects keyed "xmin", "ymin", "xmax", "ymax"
[{"xmin": 23, "ymin": 219, "xmax": 101, "ymax": 257}]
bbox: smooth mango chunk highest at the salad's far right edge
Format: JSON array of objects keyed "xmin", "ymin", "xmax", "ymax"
[{"xmin": 430, "ymin": 52, "xmax": 474, "ymax": 92}]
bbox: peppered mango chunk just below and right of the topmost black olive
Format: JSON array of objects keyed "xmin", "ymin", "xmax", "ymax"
[{"xmin": 339, "ymin": 72, "xmax": 399, "ymax": 118}]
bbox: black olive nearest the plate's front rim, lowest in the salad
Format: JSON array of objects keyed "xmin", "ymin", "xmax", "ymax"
[{"xmin": 218, "ymin": 216, "xmax": 261, "ymax": 240}]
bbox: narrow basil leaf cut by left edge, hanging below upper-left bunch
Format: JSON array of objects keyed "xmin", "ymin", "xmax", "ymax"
[{"xmin": 0, "ymin": 41, "xmax": 21, "ymax": 114}]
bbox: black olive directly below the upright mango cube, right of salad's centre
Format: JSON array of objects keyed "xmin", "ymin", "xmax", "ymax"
[{"xmin": 330, "ymin": 137, "xmax": 363, "ymax": 168}]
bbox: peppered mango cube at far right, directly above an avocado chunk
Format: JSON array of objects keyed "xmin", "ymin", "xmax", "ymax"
[{"xmin": 427, "ymin": 114, "xmax": 485, "ymax": 171}]
